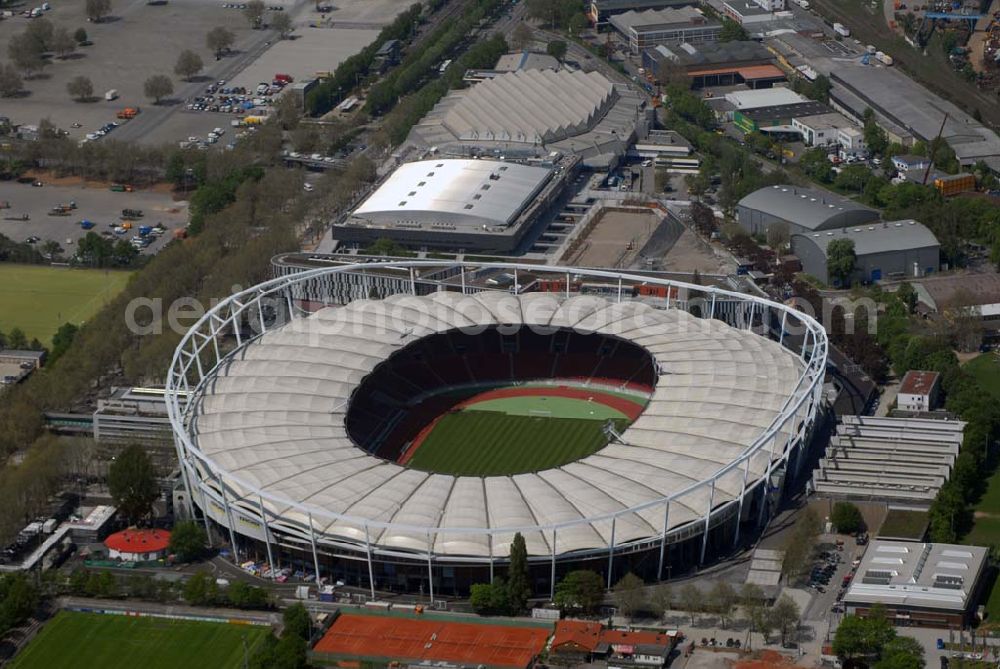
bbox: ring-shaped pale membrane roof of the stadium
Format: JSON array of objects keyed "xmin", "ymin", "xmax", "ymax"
[{"xmin": 189, "ymin": 292, "xmax": 808, "ymax": 557}]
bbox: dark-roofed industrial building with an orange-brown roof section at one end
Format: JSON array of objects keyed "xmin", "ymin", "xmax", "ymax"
[{"xmin": 642, "ymin": 40, "xmax": 785, "ymax": 88}]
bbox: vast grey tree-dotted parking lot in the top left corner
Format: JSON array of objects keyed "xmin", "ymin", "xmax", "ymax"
[{"xmin": 0, "ymin": 0, "xmax": 405, "ymax": 143}]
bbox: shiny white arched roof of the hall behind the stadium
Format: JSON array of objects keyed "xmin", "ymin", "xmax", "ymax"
[{"xmin": 353, "ymin": 158, "xmax": 552, "ymax": 228}]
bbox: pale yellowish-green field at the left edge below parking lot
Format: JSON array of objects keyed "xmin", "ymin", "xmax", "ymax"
[{"xmin": 0, "ymin": 263, "xmax": 131, "ymax": 345}]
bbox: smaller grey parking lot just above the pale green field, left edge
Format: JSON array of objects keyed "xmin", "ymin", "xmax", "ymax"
[{"xmin": 0, "ymin": 179, "xmax": 188, "ymax": 256}]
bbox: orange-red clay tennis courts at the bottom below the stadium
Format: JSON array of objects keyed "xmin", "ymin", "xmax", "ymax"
[{"xmin": 313, "ymin": 613, "xmax": 552, "ymax": 667}]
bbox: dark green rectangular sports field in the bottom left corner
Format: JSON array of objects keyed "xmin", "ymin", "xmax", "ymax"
[{"xmin": 11, "ymin": 611, "xmax": 270, "ymax": 669}]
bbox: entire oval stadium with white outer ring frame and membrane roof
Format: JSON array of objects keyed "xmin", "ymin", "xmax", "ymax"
[{"xmin": 167, "ymin": 260, "xmax": 827, "ymax": 599}]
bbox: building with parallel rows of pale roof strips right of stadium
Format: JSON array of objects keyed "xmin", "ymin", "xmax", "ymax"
[{"xmin": 811, "ymin": 416, "xmax": 965, "ymax": 507}]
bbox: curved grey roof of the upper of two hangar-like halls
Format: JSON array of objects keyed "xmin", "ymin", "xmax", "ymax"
[{"xmin": 739, "ymin": 185, "xmax": 878, "ymax": 230}]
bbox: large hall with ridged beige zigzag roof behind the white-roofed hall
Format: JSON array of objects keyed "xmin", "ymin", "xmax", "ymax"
[{"xmin": 408, "ymin": 70, "xmax": 648, "ymax": 170}]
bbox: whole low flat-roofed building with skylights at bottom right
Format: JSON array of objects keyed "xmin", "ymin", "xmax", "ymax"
[{"xmin": 844, "ymin": 539, "xmax": 989, "ymax": 629}]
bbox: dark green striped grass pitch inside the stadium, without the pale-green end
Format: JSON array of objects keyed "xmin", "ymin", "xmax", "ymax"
[{"xmin": 408, "ymin": 408, "xmax": 627, "ymax": 476}]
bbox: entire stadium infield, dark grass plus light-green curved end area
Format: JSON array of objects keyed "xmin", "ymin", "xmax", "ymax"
[{"xmin": 407, "ymin": 397, "xmax": 629, "ymax": 476}]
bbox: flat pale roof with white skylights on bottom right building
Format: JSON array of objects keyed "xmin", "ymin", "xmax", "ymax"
[{"xmin": 844, "ymin": 539, "xmax": 987, "ymax": 612}]
